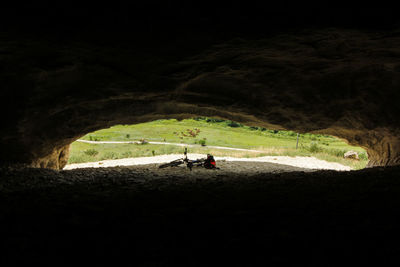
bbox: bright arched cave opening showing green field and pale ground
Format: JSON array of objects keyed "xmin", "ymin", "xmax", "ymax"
[{"xmin": 64, "ymin": 117, "xmax": 368, "ymax": 170}]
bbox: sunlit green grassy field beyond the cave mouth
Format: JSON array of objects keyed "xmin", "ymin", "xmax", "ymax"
[{"xmin": 69, "ymin": 118, "xmax": 368, "ymax": 169}]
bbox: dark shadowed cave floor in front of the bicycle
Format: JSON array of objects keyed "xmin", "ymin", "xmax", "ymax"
[{"xmin": 0, "ymin": 164, "xmax": 400, "ymax": 266}]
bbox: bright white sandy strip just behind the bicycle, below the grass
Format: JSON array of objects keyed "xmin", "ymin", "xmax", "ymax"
[{"xmin": 64, "ymin": 153, "xmax": 351, "ymax": 171}]
